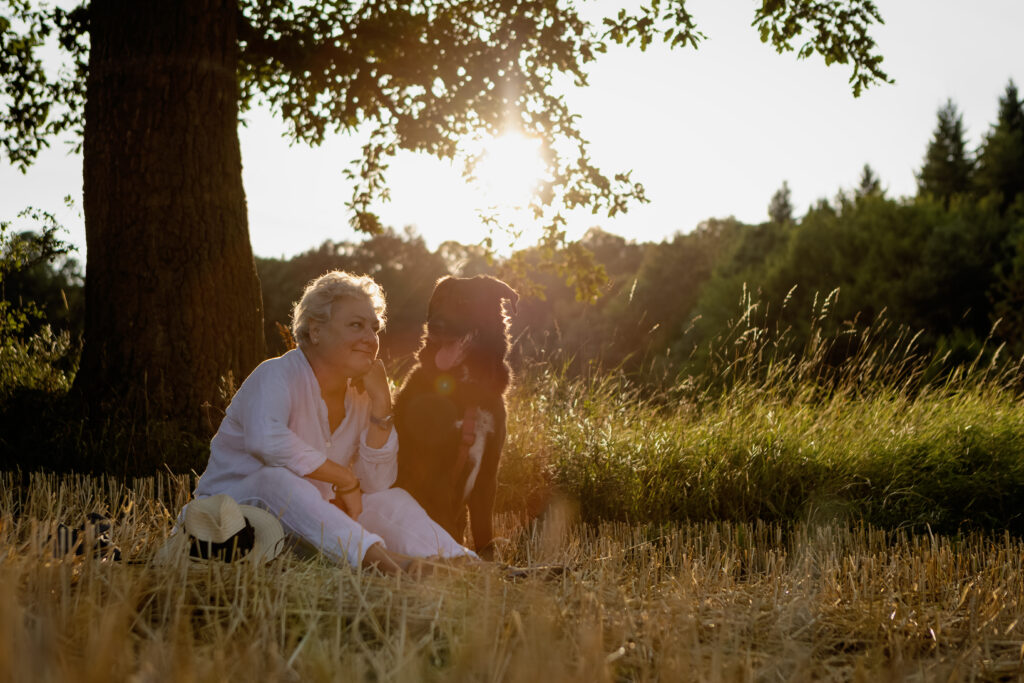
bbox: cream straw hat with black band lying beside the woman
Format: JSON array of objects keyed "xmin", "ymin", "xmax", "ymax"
[{"xmin": 154, "ymin": 494, "xmax": 285, "ymax": 564}]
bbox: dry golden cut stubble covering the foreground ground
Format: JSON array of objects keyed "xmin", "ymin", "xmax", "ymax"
[{"xmin": 0, "ymin": 475, "xmax": 1024, "ymax": 683}]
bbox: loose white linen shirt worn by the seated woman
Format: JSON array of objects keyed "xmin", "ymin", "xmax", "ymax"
[{"xmin": 196, "ymin": 348, "xmax": 398, "ymax": 500}]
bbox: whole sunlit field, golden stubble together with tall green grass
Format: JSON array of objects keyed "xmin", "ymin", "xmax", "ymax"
[{"xmin": 6, "ymin": 307, "xmax": 1024, "ymax": 681}]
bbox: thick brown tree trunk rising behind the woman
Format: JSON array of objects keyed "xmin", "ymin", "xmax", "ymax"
[{"xmin": 75, "ymin": 0, "xmax": 264, "ymax": 458}]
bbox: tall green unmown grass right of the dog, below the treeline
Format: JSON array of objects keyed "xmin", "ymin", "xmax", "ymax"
[{"xmin": 499, "ymin": 293, "xmax": 1024, "ymax": 535}]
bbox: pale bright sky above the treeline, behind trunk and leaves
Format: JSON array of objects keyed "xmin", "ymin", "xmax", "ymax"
[{"xmin": 0, "ymin": 0, "xmax": 1024, "ymax": 256}]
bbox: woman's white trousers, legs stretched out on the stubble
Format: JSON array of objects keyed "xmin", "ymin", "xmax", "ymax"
[{"xmin": 217, "ymin": 467, "xmax": 476, "ymax": 566}]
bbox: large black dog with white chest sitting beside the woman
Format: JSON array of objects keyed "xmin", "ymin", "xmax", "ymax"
[{"xmin": 394, "ymin": 275, "xmax": 519, "ymax": 558}]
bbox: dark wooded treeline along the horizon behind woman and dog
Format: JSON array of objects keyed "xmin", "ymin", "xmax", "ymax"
[{"xmin": 0, "ymin": 81, "xmax": 1024, "ymax": 395}]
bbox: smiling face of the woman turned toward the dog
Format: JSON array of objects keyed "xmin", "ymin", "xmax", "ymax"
[{"xmin": 309, "ymin": 297, "xmax": 381, "ymax": 377}]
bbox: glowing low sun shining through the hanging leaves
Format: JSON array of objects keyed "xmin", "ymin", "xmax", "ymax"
[{"xmin": 473, "ymin": 133, "xmax": 546, "ymax": 212}]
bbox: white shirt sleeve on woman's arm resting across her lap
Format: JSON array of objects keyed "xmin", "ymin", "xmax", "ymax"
[{"xmin": 234, "ymin": 373, "xmax": 327, "ymax": 476}]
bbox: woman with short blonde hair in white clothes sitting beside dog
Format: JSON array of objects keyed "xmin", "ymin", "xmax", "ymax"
[{"xmin": 195, "ymin": 270, "xmax": 474, "ymax": 572}]
